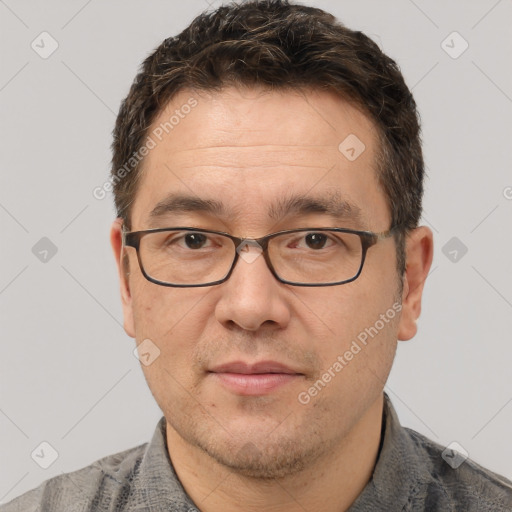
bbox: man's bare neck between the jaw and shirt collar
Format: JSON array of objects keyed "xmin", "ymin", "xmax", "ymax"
[{"xmin": 167, "ymin": 394, "xmax": 383, "ymax": 512}]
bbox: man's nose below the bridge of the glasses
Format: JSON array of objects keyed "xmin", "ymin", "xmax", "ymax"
[{"xmin": 215, "ymin": 244, "xmax": 290, "ymax": 331}]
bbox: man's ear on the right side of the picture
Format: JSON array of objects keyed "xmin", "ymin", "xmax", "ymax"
[{"xmin": 398, "ymin": 226, "xmax": 434, "ymax": 341}]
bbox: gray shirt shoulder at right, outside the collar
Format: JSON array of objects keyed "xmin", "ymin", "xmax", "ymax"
[{"xmin": 404, "ymin": 427, "xmax": 512, "ymax": 512}]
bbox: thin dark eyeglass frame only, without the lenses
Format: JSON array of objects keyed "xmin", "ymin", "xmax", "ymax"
[{"xmin": 122, "ymin": 225, "xmax": 399, "ymax": 288}]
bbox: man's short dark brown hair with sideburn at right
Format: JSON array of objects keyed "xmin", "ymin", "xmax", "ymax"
[{"xmin": 111, "ymin": 0, "xmax": 424, "ymax": 277}]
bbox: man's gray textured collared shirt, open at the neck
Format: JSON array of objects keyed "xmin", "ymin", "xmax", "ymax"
[{"xmin": 4, "ymin": 394, "xmax": 512, "ymax": 512}]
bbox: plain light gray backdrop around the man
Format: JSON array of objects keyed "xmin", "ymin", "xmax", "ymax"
[{"xmin": 0, "ymin": 0, "xmax": 512, "ymax": 502}]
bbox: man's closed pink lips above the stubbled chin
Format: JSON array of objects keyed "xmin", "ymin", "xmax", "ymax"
[{"xmin": 208, "ymin": 361, "xmax": 304, "ymax": 396}]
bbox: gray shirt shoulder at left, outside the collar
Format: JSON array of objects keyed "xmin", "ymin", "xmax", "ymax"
[{"xmin": 0, "ymin": 443, "xmax": 148, "ymax": 512}]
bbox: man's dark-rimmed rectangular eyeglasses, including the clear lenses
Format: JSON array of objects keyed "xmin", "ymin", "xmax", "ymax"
[{"xmin": 123, "ymin": 226, "xmax": 398, "ymax": 288}]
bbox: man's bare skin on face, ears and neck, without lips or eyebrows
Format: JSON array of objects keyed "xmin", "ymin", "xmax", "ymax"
[{"xmin": 111, "ymin": 87, "xmax": 433, "ymax": 512}]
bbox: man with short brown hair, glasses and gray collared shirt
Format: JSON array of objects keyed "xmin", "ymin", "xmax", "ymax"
[{"xmin": 2, "ymin": 0, "xmax": 512, "ymax": 512}]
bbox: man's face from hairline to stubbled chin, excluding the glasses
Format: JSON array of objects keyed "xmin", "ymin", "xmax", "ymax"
[{"xmin": 112, "ymin": 88, "xmax": 428, "ymax": 478}]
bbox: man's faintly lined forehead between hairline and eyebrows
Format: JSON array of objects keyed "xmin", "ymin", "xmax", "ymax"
[{"xmin": 132, "ymin": 88, "xmax": 387, "ymax": 229}]
